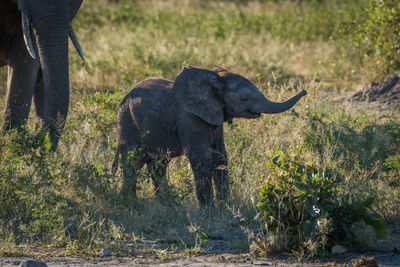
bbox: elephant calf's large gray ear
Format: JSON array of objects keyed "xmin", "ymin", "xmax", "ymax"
[{"xmin": 173, "ymin": 67, "xmax": 224, "ymax": 126}]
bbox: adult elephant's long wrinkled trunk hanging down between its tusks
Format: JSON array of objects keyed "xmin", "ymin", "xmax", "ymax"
[{"xmin": 34, "ymin": 16, "xmax": 71, "ymax": 150}]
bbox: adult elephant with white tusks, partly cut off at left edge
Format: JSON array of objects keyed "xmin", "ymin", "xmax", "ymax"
[{"xmin": 0, "ymin": 0, "xmax": 83, "ymax": 150}]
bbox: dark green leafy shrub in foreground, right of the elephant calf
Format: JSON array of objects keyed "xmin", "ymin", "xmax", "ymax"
[{"xmin": 257, "ymin": 152, "xmax": 385, "ymax": 257}]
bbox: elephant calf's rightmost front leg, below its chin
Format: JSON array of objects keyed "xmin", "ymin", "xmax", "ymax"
[{"xmin": 212, "ymin": 127, "xmax": 229, "ymax": 203}]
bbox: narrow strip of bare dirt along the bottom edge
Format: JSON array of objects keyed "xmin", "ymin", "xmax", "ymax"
[{"xmin": 0, "ymin": 253, "xmax": 400, "ymax": 267}]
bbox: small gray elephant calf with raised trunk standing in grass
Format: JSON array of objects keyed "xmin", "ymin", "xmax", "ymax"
[{"xmin": 113, "ymin": 67, "xmax": 307, "ymax": 207}]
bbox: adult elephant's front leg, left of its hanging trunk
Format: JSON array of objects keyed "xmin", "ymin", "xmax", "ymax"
[{"xmin": 4, "ymin": 39, "xmax": 40, "ymax": 130}]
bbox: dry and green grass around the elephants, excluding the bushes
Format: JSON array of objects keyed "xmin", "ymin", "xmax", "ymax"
[{"xmin": 0, "ymin": 0, "xmax": 400, "ymax": 259}]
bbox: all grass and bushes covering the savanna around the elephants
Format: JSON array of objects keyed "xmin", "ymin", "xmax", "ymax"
[{"xmin": 0, "ymin": 0, "xmax": 400, "ymax": 258}]
